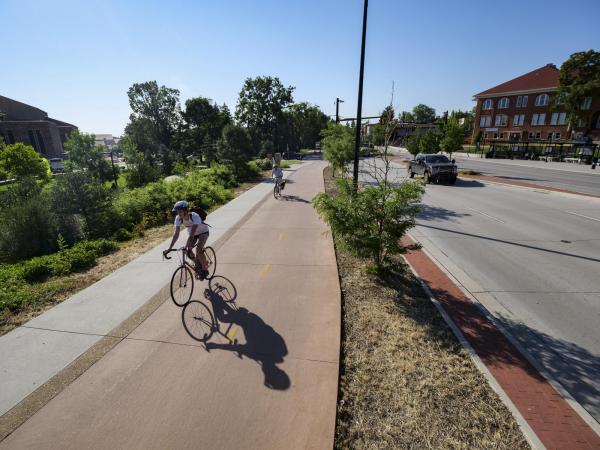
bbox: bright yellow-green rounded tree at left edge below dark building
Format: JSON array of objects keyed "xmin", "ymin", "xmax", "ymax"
[{"xmin": 0, "ymin": 142, "xmax": 51, "ymax": 180}]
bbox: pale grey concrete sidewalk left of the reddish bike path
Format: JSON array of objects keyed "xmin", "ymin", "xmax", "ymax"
[{"xmin": 0, "ymin": 163, "xmax": 302, "ymax": 416}]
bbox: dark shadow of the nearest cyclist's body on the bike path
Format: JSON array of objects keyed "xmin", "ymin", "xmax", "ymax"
[{"xmin": 204, "ymin": 282, "xmax": 290, "ymax": 390}]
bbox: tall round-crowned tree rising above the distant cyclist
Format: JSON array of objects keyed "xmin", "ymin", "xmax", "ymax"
[{"xmin": 235, "ymin": 77, "xmax": 295, "ymax": 148}]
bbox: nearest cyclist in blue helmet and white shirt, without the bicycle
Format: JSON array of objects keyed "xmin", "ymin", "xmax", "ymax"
[{"xmin": 163, "ymin": 200, "xmax": 208, "ymax": 280}]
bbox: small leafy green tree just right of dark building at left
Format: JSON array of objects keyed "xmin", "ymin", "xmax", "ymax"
[{"xmin": 65, "ymin": 130, "xmax": 116, "ymax": 182}]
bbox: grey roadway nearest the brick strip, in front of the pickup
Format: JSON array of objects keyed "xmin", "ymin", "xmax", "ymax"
[{"xmin": 361, "ymin": 160, "xmax": 600, "ymax": 422}]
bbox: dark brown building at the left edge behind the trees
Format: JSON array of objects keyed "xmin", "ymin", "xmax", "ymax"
[{"xmin": 0, "ymin": 95, "xmax": 77, "ymax": 159}]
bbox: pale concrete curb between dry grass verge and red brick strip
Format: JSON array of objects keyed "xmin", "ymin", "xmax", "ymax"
[{"xmin": 404, "ymin": 259, "xmax": 546, "ymax": 450}]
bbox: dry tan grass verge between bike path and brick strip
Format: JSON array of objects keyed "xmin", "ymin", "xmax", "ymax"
[{"xmin": 325, "ymin": 169, "xmax": 529, "ymax": 449}]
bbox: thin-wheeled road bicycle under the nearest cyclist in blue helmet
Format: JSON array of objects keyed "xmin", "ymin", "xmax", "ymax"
[{"xmin": 163, "ymin": 247, "xmax": 217, "ymax": 306}]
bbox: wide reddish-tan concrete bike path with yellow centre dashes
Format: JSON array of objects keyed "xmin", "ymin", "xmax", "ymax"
[{"xmin": 0, "ymin": 162, "xmax": 340, "ymax": 449}]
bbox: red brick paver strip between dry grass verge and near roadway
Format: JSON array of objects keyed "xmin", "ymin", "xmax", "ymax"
[{"xmin": 403, "ymin": 237, "xmax": 600, "ymax": 450}]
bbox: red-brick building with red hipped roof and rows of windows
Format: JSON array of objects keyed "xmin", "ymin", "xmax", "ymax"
[{"xmin": 474, "ymin": 64, "xmax": 600, "ymax": 142}]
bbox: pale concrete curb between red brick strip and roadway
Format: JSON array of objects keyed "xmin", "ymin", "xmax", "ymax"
[{"xmin": 407, "ymin": 233, "xmax": 600, "ymax": 435}]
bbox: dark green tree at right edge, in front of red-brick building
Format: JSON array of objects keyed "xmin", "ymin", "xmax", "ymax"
[{"xmin": 558, "ymin": 50, "xmax": 600, "ymax": 133}]
